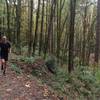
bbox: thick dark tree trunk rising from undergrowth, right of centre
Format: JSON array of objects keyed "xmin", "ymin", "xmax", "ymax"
[{"xmin": 68, "ymin": 0, "xmax": 76, "ymax": 73}]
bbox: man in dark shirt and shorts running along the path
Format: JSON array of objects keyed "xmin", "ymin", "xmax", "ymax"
[{"xmin": 0, "ymin": 36, "xmax": 11, "ymax": 75}]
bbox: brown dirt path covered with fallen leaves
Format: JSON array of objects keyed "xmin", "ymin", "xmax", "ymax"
[{"xmin": 0, "ymin": 65, "xmax": 59, "ymax": 100}]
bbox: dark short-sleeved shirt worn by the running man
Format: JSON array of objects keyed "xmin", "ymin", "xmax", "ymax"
[{"xmin": 0, "ymin": 42, "xmax": 11, "ymax": 56}]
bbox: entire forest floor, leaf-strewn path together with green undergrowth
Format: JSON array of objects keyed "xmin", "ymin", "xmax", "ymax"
[{"xmin": 0, "ymin": 54, "xmax": 100, "ymax": 100}]
